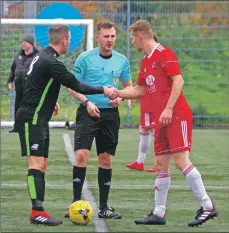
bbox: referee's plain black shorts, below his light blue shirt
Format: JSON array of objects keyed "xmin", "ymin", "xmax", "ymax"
[{"xmin": 74, "ymin": 105, "xmax": 120, "ymax": 155}]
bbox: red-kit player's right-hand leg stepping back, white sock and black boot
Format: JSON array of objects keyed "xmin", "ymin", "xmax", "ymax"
[{"xmin": 173, "ymin": 150, "xmax": 218, "ymax": 226}]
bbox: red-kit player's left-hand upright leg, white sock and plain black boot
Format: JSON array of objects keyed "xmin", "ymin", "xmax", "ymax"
[{"xmin": 135, "ymin": 155, "xmax": 171, "ymax": 225}]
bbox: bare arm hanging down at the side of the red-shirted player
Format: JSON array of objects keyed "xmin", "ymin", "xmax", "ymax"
[{"xmin": 159, "ymin": 74, "xmax": 184, "ymax": 125}]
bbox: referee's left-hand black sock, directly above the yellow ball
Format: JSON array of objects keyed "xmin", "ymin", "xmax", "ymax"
[{"xmin": 73, "ymin": 166, "xmax": 86, "ymax": 202}]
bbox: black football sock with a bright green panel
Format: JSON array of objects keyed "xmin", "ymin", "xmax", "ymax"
[{"xmin": 27, "ymin": 169, "xmax": 45, "ymax": 211}]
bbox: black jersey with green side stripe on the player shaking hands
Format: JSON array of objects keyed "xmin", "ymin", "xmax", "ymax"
[{"xmin": 16, "ymin": 46, "xmax": 103, "ymax": 125}]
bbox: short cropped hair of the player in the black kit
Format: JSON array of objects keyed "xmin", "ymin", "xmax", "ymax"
[{"xmin": 49, "ymin": 24, "xmax": 69, "ymax": 45}]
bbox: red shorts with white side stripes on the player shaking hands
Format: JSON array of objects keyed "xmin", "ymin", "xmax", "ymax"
[{"xmin": 154, "ymin": 120, "xmax": 192, "ymax": 155}]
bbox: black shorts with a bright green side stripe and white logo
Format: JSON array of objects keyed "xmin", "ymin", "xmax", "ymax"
[{"xmin": 15, "ymin": 122, "xmax": 50, "ymax": 158}]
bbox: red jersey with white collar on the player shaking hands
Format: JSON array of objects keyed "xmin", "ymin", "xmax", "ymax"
[{"xmin": 137, "ymin": 44, "xmax": 192, "ymax": 124}]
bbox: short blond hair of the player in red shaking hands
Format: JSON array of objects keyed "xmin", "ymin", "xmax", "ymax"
[{"xmin": 129, "ymin": 19, "xmax": 158, "ymax": 42}]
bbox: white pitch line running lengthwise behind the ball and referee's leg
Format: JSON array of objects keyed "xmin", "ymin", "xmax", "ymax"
[{"xmin": 63, "ymin": 133, "xmax": 108, "ymax": 232}]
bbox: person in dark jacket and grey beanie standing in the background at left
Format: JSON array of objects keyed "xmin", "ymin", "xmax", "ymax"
[{"xmin": 8, "ymin": 35, "xmax": 39, "ymax": 124}]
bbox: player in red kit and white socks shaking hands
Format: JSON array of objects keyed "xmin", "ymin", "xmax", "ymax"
[{"xmin": 109, "ymin": 20, "xmax": 218, "ymax": 226}]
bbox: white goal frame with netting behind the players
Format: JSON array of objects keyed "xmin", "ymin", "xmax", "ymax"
[{"xmin": 0, "ymin": 18, "xmax": 94, "ymax": 128}]
